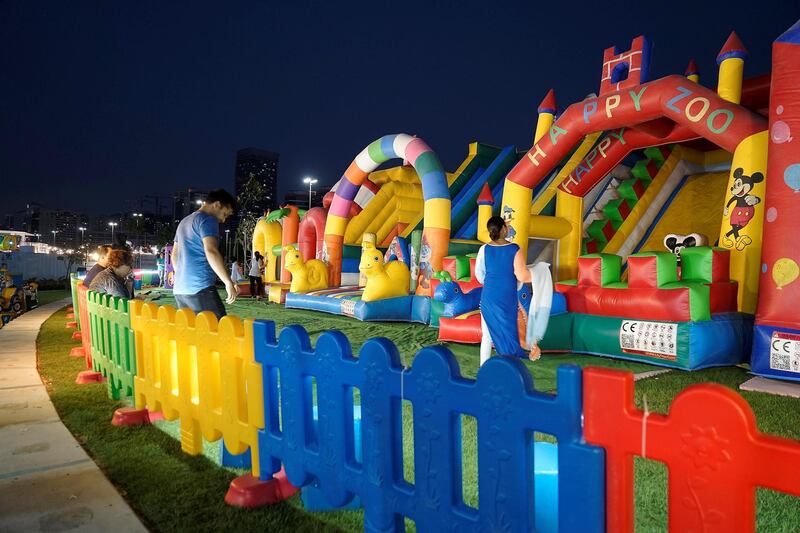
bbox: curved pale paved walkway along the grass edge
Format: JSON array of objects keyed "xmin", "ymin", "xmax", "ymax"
[{"xmin": 0, "ymin": 299, "xmax": 147, "ymax": 533}]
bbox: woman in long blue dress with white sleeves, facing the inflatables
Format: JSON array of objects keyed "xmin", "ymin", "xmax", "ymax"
[{"xmin": 475, "ymin": 217, "xmax": 541, "ymax": 365}]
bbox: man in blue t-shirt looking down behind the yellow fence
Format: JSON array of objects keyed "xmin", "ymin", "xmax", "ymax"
[{"xmin": 172, "ymin": 189, "xmax": 239, "ymax": 319}]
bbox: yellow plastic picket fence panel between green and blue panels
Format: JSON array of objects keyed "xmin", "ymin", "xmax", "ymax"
[{"xmin": 130, "ymin": 300, "xmax": 264, "ymax": 475}]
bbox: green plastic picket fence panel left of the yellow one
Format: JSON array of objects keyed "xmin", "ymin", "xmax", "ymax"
[{"xmin": 87, "ymin": 291, "xmax": 136, "ymax": 400}]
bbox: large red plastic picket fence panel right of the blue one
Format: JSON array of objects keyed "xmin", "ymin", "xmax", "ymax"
[{"xmin": 584, "ymin": 368, "xmax": 800, "ymax": 533}]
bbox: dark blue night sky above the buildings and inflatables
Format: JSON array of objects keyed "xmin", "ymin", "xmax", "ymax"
[{"xmin": 0, "ymin": 0, "xmax": 800, "ymax": 215}]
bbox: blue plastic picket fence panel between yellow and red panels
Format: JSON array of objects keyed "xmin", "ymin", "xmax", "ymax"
[{"xmin": 253, "ymin": 321, "xmax": 605, "ymax": 532}]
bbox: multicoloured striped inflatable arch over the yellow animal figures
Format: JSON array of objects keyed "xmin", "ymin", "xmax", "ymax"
[{"xmin": 324, "ymin": 133, "xmax": 450, "ymax": 295}]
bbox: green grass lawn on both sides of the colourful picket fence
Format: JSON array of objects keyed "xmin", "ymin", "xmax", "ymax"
[{"xmin": 38, "ymin": 295, "xmax": 800, "ymax": 532}]
